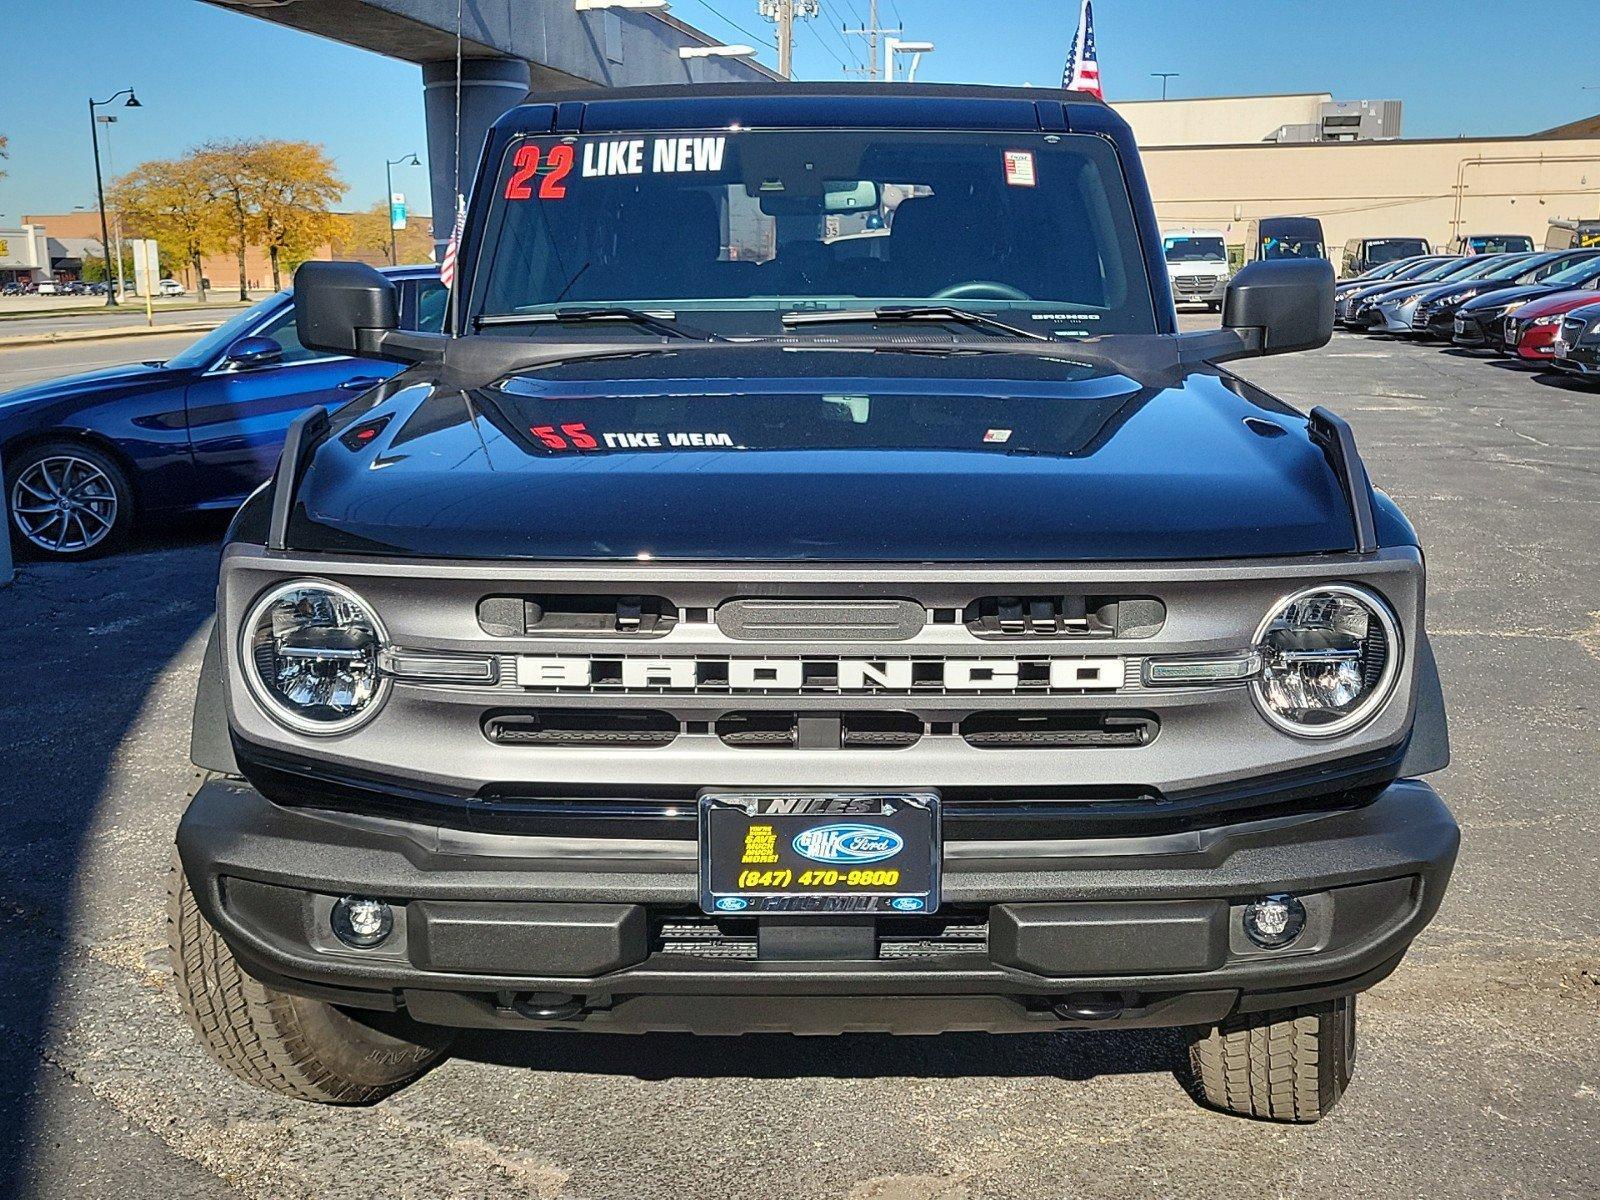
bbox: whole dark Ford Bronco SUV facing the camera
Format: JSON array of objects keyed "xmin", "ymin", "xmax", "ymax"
[{"xmin": 171, "ymin": 85, "xmax": 1459, "ymax": 1122}]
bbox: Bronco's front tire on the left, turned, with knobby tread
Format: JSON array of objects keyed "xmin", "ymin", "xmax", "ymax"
[{"xmin": 166, "ymin": 851, "xmax": 450, "ymax": 1104}]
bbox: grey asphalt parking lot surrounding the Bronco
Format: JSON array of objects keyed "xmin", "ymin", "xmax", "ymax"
[{"xmin": 0, "ymin": 326, "xmax": 1600, "ymax": 1200}]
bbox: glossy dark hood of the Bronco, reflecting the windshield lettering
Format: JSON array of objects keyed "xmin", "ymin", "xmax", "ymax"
[{"xmin": 290, "ymin": 346, "xmax": 1354, "ymax": 562}]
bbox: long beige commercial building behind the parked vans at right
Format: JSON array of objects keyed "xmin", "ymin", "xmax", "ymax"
[{"xmin": 1112, "ymin": 93, "xmax": 1600, "ymax": 267}]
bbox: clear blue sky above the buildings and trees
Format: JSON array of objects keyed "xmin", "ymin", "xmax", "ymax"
[{"xmin": 0, "ymin": 0, "xmax": 1600, "ymax": 222}]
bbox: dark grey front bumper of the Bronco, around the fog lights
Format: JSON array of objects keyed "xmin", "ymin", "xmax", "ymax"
[{"xmin": 178, "ymin": 779, "xmax": 1459, "ymax": 1032}]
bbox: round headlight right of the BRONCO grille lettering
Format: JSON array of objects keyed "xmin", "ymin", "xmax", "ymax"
[{"xmin": 1253, "ymin": 584, "xmax": 1400, "ymax": 738}]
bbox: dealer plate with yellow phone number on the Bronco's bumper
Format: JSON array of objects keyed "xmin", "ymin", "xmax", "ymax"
[{"xmin": 698, "ymin": 789, "xmax": 942, "ymax": 917}]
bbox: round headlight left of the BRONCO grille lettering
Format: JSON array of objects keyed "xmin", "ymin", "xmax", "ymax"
[{"xmin": 240, "ymin": 579, "xmax": 387, "ymax": 733}]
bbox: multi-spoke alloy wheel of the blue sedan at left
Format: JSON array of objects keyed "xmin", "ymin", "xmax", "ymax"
[{"xmin": 5, "ymin": 442, "xmax": 133, "ymax": 558}]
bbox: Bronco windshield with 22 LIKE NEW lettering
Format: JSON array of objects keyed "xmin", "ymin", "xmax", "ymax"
[{"xmin": 470, "ymin": 130, "xmax": 1155, "ymax": 338}]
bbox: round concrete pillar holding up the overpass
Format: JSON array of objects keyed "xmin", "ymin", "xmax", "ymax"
[{"xmin": 422, "ymin": 58, "xmax": 530, "ymax": 258}]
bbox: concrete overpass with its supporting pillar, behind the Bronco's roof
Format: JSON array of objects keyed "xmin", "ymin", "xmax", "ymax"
[{"xmin": 205, "ymin": 0, "xmax": 778, "ymax": 249}]
